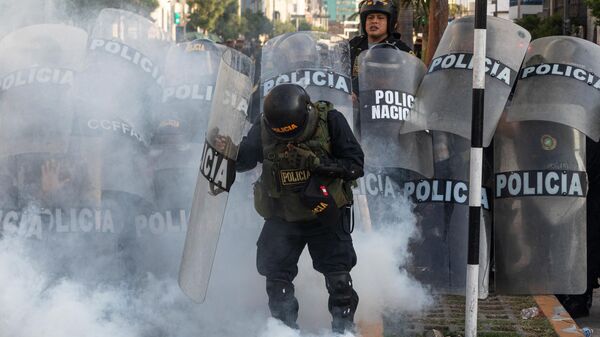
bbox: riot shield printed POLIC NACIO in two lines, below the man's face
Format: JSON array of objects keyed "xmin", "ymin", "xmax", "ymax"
[{"xmin": 358, "ymin": 46, "xmax": 433, "ymax": 177}]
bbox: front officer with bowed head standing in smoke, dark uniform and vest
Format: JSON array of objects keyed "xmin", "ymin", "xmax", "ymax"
[{"xmin": 236, "ymin": 84, "xmax": 364, "ymax": 333}]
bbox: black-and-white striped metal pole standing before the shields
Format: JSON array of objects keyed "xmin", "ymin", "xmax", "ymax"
[{"xmin": 465, "ymin": 0, "xmax": 487, "ymax": 337}]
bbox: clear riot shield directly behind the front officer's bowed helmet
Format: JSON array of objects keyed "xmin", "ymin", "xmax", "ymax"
[{"xmin": 260, "ymin": 32, "xmax": 354, "ymax": 126}]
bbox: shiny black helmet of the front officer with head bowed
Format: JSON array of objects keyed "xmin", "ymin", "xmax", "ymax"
[{"xmin": 263, "ymin": 83, "xmax": 314, "ymax": 140}]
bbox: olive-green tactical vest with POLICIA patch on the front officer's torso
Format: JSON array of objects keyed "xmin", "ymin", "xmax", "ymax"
[{"xmin": 254, "ymin": 101, "xmax": 352, "ymax": 222}]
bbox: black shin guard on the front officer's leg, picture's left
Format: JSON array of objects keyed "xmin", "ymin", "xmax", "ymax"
[{"xmin": 267, "ymin": 279, "xmax": 298, "ymax": 329}]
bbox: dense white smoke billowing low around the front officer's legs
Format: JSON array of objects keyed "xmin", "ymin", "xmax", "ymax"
[{"xmin": 0, "ymin": 181, "xmax": 429, "ymax": 337}]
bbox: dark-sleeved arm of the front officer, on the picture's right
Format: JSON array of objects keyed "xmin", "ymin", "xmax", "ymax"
[{"xmin": 317, "ymin": 110, "xmax": 365, "ymax": 180}]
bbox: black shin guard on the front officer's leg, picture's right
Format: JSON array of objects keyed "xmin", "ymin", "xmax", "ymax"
[{"xmin": 325, "ymin": 272, "xmax": 358, "ymax": 333}]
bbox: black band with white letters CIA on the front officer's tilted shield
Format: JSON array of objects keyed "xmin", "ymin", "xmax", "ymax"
[{"xmin": 200, "ymin": 142, "xmax": 235, "ymax": 192}]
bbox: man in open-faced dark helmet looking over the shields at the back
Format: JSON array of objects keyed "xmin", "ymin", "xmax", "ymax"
[{"xmin": 350, "ymin": 0, "xmax": 412, "ymax": 92}]
